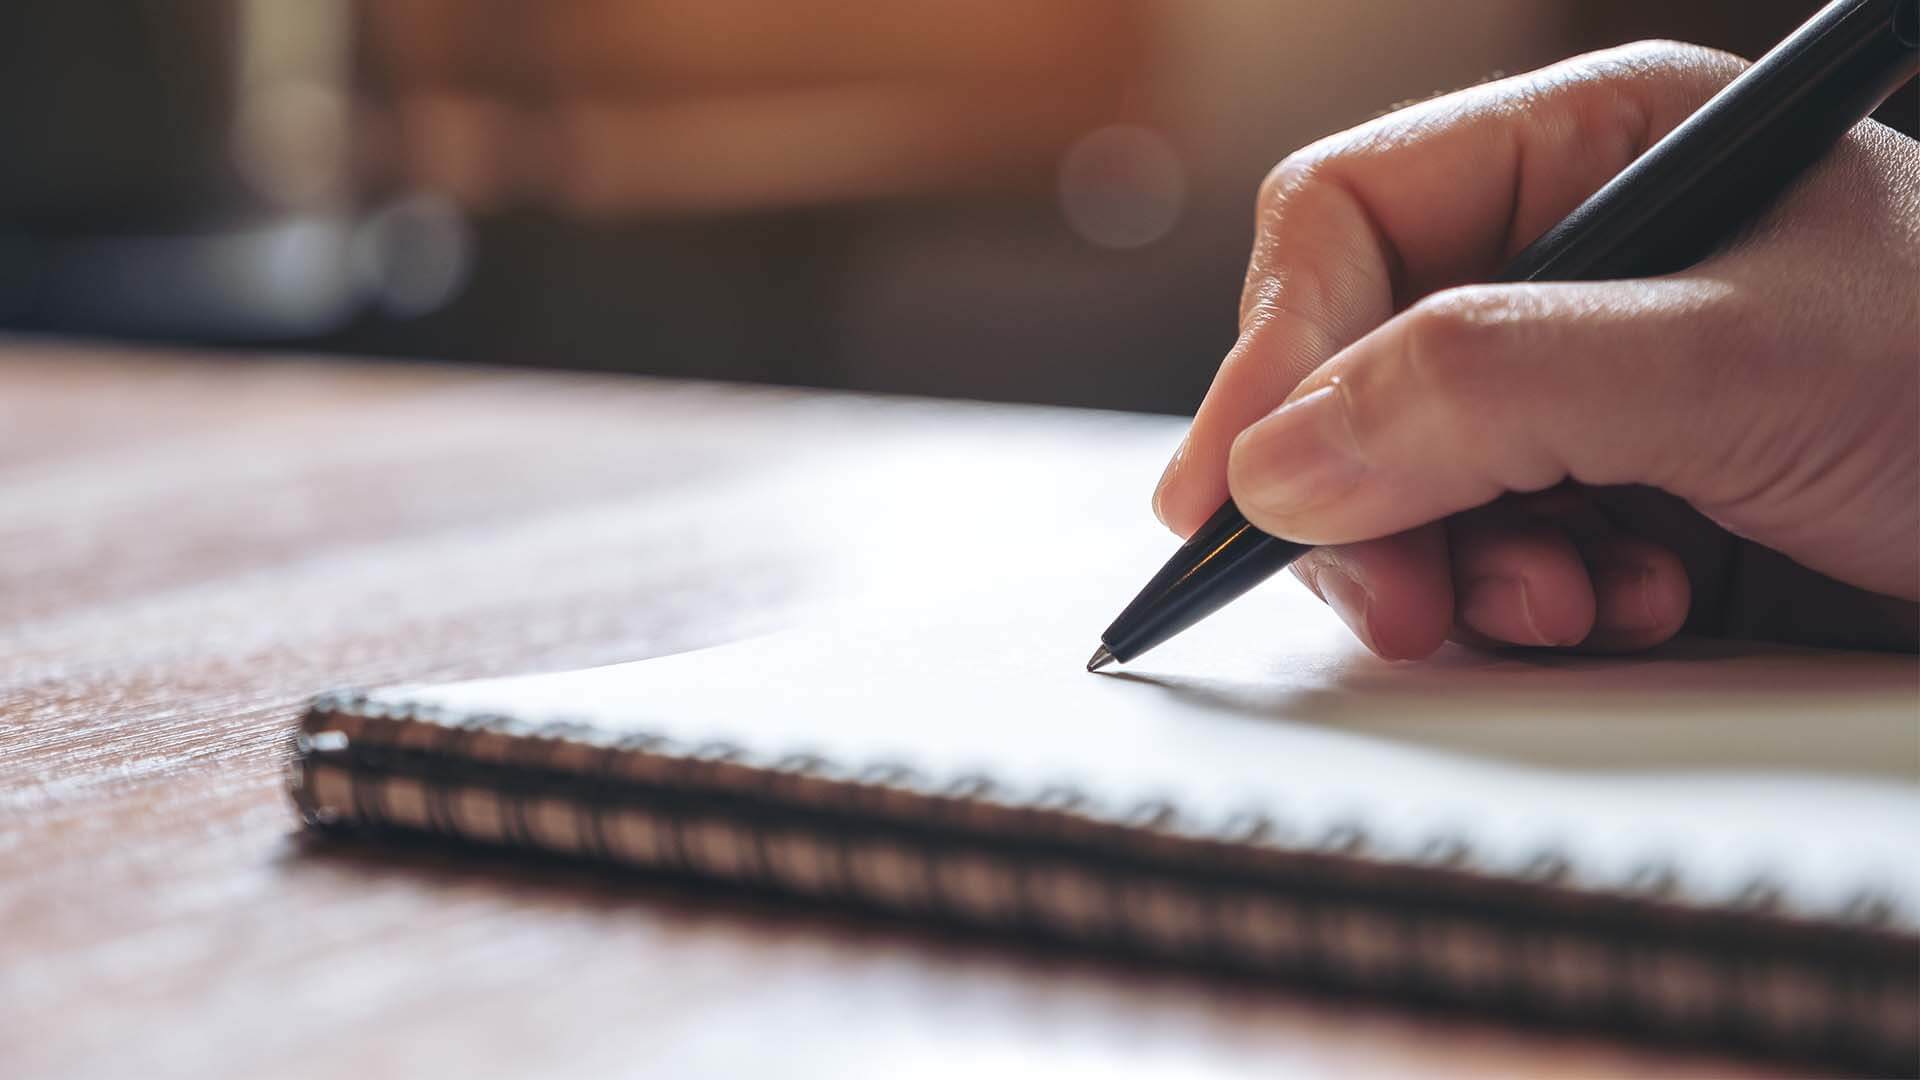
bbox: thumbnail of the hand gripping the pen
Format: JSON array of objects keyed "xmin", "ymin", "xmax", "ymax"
[{"xmin": 1233, "ymin": 384, "xmax": 1365, "ymax": 515}]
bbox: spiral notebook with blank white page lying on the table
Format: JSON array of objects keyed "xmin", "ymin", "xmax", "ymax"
[{"xmin": 292, "ymin": 545, "xmax": 1920, "ymax": 1070}]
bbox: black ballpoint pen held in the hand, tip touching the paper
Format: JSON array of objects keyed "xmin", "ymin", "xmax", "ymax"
[{"xmin": 1087, "ymin": 0, "xmax": 1920, "ymax": 671}]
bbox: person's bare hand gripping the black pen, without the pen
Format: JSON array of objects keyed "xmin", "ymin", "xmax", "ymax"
[{"xmin": 1154, "ymin": 42, "xmax": 1920, "ymax": 659}]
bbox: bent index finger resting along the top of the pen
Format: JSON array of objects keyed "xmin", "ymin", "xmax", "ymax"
[{"xmin": 1154, "ymin": 42, "xmax": 1741, "ymax": 536}]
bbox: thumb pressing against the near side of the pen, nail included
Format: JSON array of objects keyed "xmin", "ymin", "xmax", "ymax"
[{"xmin": 1227, "ymin": 279, "xmax": 1778, "ymax": 544}]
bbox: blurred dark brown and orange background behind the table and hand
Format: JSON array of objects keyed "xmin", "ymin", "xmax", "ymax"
[{"xmin": 0, "ymin": 0, "xmax": 1896, "ymax": 411}]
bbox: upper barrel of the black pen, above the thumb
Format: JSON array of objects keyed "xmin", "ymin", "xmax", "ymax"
[{"xmin": 1496, "ymin": 0, "xmax": 1920, "ymax": 281}]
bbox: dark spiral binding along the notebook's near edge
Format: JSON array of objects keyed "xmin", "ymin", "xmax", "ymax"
[{"xmin": 288, "ymin": 696, "xmax": 1920, "ymax": 1068}]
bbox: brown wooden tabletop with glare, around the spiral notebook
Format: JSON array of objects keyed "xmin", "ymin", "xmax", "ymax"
[{"xmin": 0, "ymin": 342, "xmax": 1781, "ymax": 1078}]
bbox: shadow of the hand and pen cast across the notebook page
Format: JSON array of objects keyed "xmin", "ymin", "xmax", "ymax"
[{"xmin": 1108, "ymin": 638, "xmax": 1920, "ymax": 780}]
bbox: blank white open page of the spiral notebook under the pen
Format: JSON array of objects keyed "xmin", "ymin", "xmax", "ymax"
[{"xmin": 376, "ymin": 564, "xmax": 1920, "ymax": 922}]
